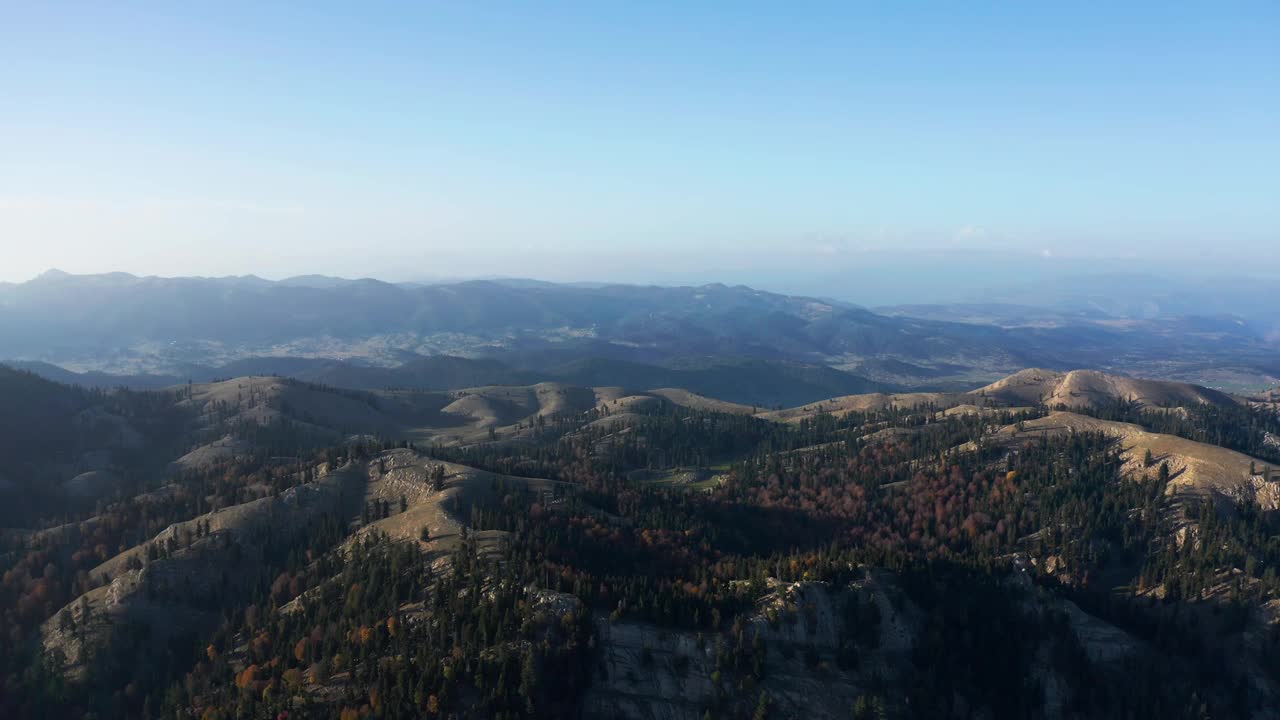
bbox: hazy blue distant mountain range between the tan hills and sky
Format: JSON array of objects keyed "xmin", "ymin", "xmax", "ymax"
[{"xmin": 0, "ymin": 272, "xmax": 1280, "ymax": 392}]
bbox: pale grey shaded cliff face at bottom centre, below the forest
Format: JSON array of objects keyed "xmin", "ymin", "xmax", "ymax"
[{"xmin": 584, "ymin": 575, "xmax": 915, "ymax": 720}]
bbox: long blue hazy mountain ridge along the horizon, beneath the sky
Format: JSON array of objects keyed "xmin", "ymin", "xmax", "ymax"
[{"xmin": 0, "ymin": 273, "xmax": 1276, "ymax": 384}]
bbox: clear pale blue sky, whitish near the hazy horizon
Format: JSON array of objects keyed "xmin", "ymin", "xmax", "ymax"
[{"xmin": 0, "ymin": 0, "xmax": 1280, "ymax": 300}]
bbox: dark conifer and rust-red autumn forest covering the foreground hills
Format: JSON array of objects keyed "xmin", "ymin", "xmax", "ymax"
[{"xmin": 0, "ymin": 371, "xmax": 1280, "ymax": 720}]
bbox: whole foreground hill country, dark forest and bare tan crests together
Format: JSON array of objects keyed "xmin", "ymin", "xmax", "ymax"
[{"xmin": 0, "ymin": 370, "xmax": 1280, "ymax": 720}]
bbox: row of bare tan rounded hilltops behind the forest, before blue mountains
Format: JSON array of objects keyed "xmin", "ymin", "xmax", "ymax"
[{"xmin": 165, "ymin": 370, "xmax": 1254, "ymax": 462}]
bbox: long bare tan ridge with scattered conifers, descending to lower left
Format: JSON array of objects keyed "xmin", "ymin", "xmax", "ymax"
[{"xmin": 41, "ymin": 450, "xmax": 583, "ymax": 678}]
